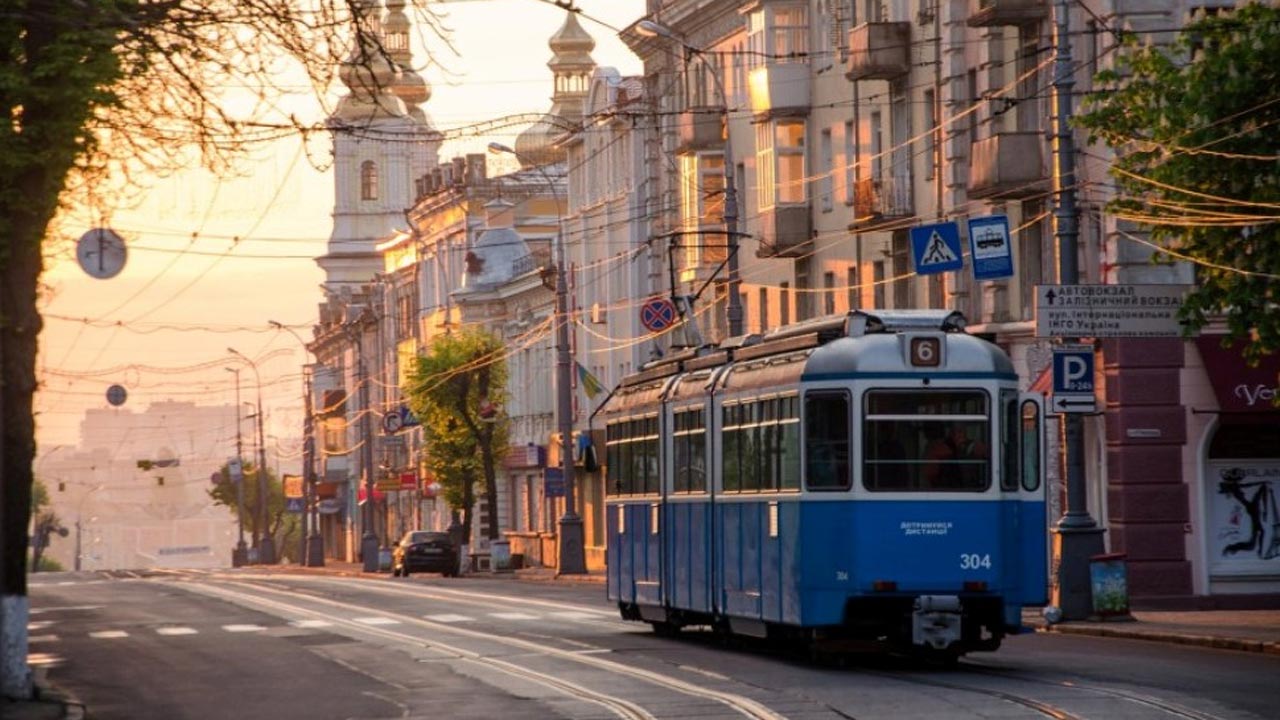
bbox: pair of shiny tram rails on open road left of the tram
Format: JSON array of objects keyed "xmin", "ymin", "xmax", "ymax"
[{"xmin": 175, "ymin": 579, "xmax": 786, "ymax": 720}]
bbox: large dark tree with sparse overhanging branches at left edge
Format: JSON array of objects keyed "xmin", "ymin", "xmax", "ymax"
[{"xmin": 0, "ymin": 0, "xmax": 447, "ymax": 698}]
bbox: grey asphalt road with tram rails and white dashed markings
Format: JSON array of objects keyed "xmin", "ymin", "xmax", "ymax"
[{"xmin": 31, "ymin": 570, "xmax": 1280, "ymax": 720}]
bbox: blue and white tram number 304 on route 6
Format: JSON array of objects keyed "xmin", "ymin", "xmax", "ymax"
[{"xmin": 599, "ymin": 310, "xmax": 1048, "ymax": 656}]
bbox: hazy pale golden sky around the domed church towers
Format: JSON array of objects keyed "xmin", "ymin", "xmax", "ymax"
[{"xmin": 36, "ymin": 0, "xmax": 644, "ymax": 455}]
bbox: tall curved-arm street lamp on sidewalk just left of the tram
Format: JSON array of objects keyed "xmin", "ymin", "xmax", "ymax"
[{"xmin": 489, "ymin": 142, "xmax": 586, "ymax": 575}]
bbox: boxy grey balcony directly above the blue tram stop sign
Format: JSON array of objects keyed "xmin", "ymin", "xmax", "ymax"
[{"xmin": 969, "ymin": 132, "xmax": 1048, "ymax": 200}]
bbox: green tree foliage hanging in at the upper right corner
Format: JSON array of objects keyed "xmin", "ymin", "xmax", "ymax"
[{"xmin": 1076, "ymin": 4, "xmax": 1280, "ymax": 361}]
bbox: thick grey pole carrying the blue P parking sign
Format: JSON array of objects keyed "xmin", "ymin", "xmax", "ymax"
[{"xmin": 1051, "ymin": 0, "xmax": 1103, "ymax": 620}]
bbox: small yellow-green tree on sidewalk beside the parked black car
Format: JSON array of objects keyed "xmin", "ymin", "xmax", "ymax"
[{"xmin": 402, "ymin": 328, "xmax": 509, "ymax": 539}]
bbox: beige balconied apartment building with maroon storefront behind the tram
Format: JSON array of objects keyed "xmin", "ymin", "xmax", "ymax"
[{"xmin": 622, "ymin": 0, "xmax": 1280, "ymax": 603}]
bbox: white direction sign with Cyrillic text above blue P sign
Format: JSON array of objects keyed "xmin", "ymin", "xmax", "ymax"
[{"xmin": 1036, "ymin": 284, "xmax": 1190, "ymax": 337}]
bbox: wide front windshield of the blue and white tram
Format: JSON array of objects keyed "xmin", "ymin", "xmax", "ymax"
[{"xmin": 863, "ymin": 389, "xmax": 992, "ymax": 492}]
